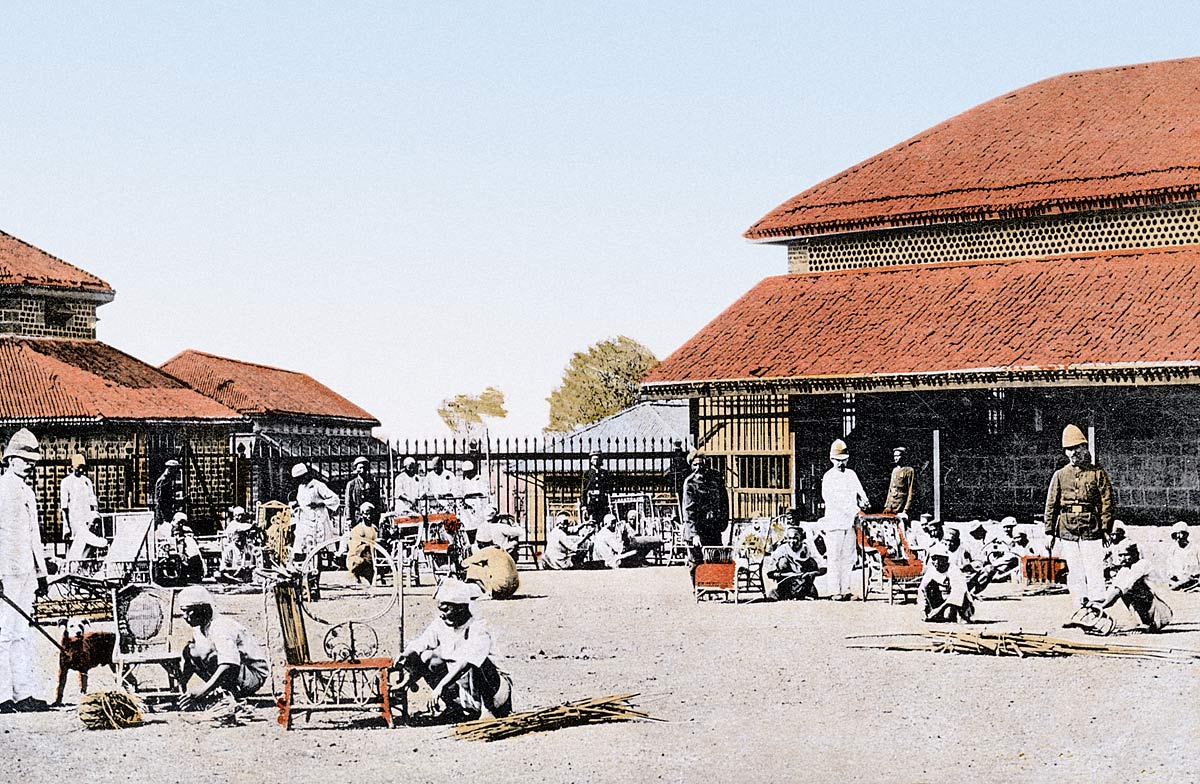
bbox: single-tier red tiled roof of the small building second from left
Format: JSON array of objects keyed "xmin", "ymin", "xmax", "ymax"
[{"xmin": 161, "ymin": 349, "xmax": 379, "ymax": 425}]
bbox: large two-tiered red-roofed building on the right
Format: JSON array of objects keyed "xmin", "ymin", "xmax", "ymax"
[{"xmin": 642, "ymin": 59, "xmax": 1200, "ymax": 522}]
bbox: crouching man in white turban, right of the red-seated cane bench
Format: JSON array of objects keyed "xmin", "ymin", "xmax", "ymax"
[{"xmin": 396, "ymin": 577, "xmax": 512, "ymax": 720}]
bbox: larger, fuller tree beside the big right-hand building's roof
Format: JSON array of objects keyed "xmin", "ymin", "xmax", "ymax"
[{"xmin": 545, "ymin": 335, "xmax": 659, "ymax": 432}]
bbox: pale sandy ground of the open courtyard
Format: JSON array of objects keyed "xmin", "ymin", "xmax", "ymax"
[{"xmin": 9, "ymin": 552, "xmax": 1200, "ymax": 784}]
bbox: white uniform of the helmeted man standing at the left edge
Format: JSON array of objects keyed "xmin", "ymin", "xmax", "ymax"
[{"xmin": 0, "ymin": 471, "xmax": 46, "ymax": 702}]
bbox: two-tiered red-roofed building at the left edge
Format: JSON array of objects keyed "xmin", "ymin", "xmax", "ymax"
[{"xmin": 0, "ymin": 232, "xmax": 242, "ymax": 543}]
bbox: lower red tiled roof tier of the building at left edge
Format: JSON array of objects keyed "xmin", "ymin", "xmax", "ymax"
[{"xmin": 0, "ymin": 337, "xmax": 241, "ymax": 419}]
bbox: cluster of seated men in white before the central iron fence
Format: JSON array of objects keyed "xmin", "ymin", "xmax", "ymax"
[{"xmin": 541, "ymin": 509, "xmax": 662, "ymax": 569}]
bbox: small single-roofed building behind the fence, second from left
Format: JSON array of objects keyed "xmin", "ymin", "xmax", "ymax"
[{"xmin": 161, "ymin": 349, "xmax": 390, "ymax": 504}]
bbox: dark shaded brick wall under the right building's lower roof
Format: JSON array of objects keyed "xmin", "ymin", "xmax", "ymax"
[{"xmin": 793, "ymin": 385, "xmax": 1200, "ymax": 525}]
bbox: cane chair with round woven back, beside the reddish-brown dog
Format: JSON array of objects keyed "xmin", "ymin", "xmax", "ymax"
[{"xmin": 113, "ymin": 585, "xmax": 184, "ymax": 701}]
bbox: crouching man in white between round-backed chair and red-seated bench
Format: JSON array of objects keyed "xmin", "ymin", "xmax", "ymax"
[{"xmin": 179, "ymin": 586, "xmax": 270, "ymax": 724}]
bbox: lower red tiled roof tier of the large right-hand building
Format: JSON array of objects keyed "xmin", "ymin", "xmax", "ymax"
[{"xmin": 643, "ymin": 246, "xmax": 1200, "ymax": 391}]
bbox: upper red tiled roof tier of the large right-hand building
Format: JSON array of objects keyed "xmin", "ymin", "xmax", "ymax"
[{"xmin": 745, "ymin": 58, "xmax": 1200, "ymax": 240}]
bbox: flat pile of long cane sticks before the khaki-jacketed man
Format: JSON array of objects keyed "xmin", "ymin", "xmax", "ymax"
[{"xmin": 847, "ymin": 629, "xmax": 1200, "ymax": 662}]
